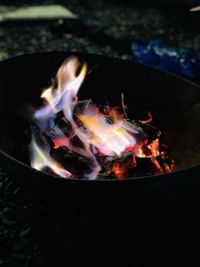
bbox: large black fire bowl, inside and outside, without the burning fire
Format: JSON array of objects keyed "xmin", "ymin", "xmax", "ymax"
[{"xmin": 0, "ymin": 53, "xmax": 200, "ymax": 266}]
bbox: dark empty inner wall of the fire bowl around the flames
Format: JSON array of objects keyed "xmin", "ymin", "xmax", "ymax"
[{"xmin": 0, "ymin": 53, "xmax": 200, "ymax": 177}]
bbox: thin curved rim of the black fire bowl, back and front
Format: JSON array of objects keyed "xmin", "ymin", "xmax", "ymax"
[{"xmin": 0, "ymin": 51, "xmax": 200, "ymax": 183}]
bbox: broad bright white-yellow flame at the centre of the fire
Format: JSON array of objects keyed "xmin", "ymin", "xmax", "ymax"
[{"xmin": 79, "ymin": 106, "xmax": 137, "ymax": 156}]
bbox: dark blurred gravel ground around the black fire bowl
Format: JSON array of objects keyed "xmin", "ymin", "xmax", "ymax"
[{"xmin": 0, "ymin": 0, "xmax": 200, "ymax": 267}]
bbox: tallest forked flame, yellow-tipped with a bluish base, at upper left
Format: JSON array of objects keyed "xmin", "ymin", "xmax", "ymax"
[{"xmin": 34, "ymin": 57, "xmax": 87, "ymax": 126}]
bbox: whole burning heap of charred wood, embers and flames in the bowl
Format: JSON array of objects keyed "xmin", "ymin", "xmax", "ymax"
[{"xmin": 29, "ymin": 57, "xmax": 173, "ymax": 180}]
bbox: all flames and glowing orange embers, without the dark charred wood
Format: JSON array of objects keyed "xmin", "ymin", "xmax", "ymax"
[{"xmin": 30, "ymin": 57, "xmax": 173, "ymax": 179}]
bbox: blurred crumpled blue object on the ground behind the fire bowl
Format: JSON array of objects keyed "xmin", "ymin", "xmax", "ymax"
[{"xmin": 132, "ymin": 40, "xmax": 200, "ymax": 78}]
